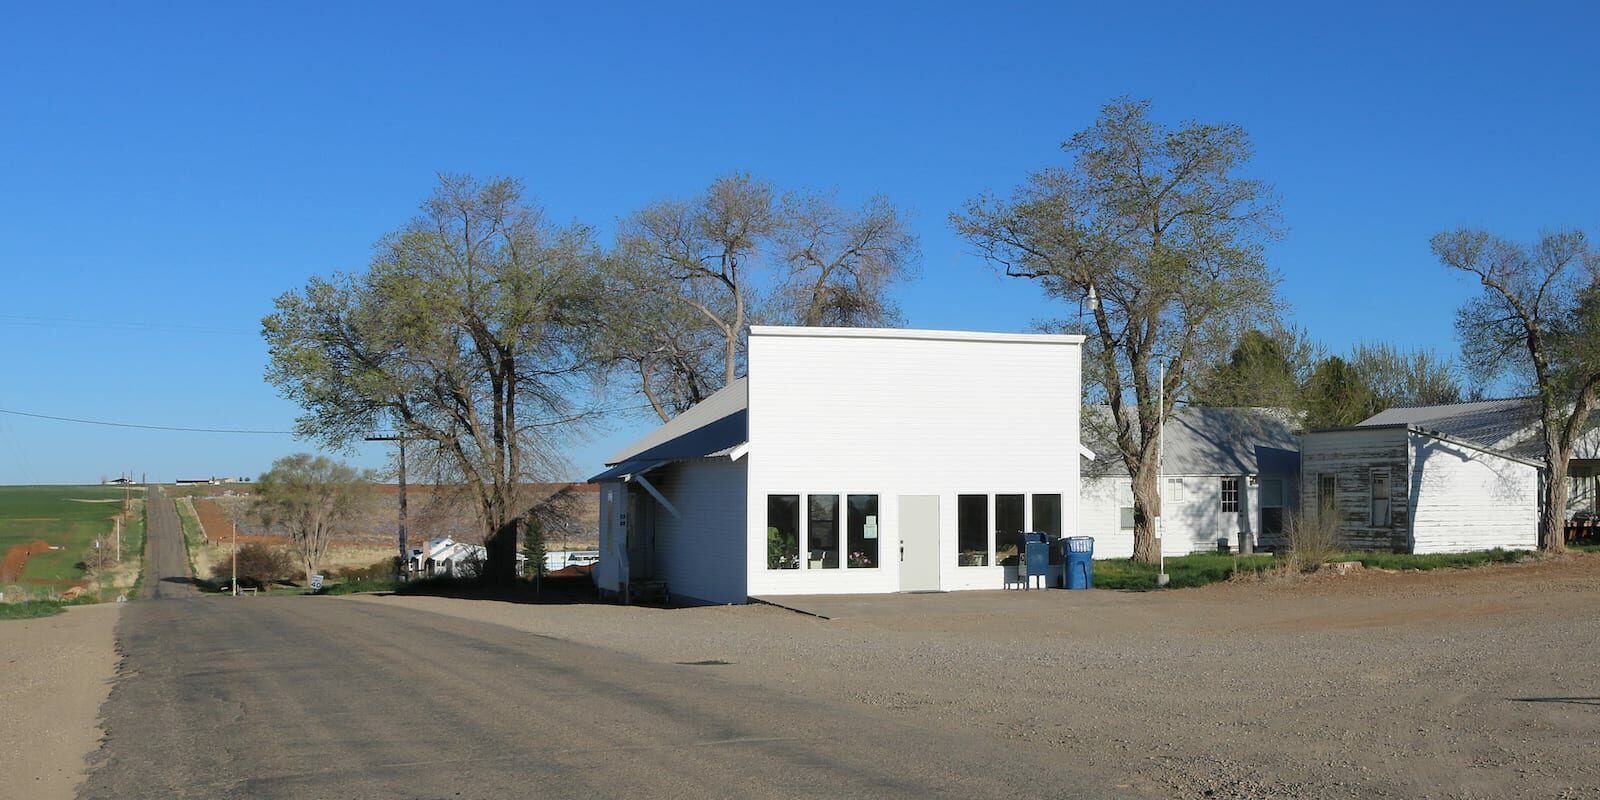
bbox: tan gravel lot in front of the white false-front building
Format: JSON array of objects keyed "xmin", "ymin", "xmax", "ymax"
[{"xmin": 357, "ymin": 554, "xmax": 1600, "ymax": 798}]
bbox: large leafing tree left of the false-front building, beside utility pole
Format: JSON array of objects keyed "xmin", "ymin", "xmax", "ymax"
[{"xmin": 262, "ymin": 176, "xmax": 598, "ymax": 581}]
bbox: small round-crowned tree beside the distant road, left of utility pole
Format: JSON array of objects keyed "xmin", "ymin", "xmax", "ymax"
[{"xmin": 251, "ymin": 453, "xmax": 371, "ymax": 586}]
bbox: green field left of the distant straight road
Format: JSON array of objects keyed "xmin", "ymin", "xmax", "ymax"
[{"xmin": 0, "ymin": 486, "xmax": 144, "ymax": 581}]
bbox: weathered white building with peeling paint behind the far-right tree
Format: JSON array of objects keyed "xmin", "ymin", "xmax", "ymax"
[{"xmin": 1301, "ymin": 398, "xmax": 1600, "ymax": 554}]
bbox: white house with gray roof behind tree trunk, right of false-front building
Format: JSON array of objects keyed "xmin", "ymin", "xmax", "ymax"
[{"xmin": 1078, "ymin": 406, "xmax": 1299, "ymax": 558}]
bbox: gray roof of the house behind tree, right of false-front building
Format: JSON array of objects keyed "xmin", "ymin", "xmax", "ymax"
[{"xmin": 1083, "ymin": 405, "xmax": 1299, "ymax": 475}]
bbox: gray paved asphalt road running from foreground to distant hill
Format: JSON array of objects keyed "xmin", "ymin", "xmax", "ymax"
[{"xmin": 82, "ymin": 501, "xmax": 1110, "ymax": 798}]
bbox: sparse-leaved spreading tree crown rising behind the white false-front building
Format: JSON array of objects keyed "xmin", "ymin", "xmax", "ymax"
[{"xmin": 598, "ymin": 174, "xmax": 917, "ymax": 421}]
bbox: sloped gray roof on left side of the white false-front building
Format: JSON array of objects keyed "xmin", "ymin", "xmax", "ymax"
[{"xmin": 589, "ymin": 378, "xmax": 750, "ymax": 483}]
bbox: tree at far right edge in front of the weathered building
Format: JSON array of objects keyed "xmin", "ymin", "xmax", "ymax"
[{"xmin": 1432, "ymin": 229, "xmax": 1600, "ymax": 550}]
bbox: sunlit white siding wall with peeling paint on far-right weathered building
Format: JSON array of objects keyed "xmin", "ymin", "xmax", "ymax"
[{"xmin": 1410, "ymin": 434, "xmax": 1539, "ymax": 554}]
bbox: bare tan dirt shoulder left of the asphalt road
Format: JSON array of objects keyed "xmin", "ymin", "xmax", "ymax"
[{"xmin": 0, "ymin": 603, "xmax": 122, "ymax": 800}]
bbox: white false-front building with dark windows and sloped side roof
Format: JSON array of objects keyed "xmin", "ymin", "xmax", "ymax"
[{"xmin": 590, "ymin": 326, "xmax": 1083, "ymax": 603}]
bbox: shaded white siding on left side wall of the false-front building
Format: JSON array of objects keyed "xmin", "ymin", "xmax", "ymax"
[{"xmin": 650, "ymin": 458, "xmax": 749, "ymax": 603}]
